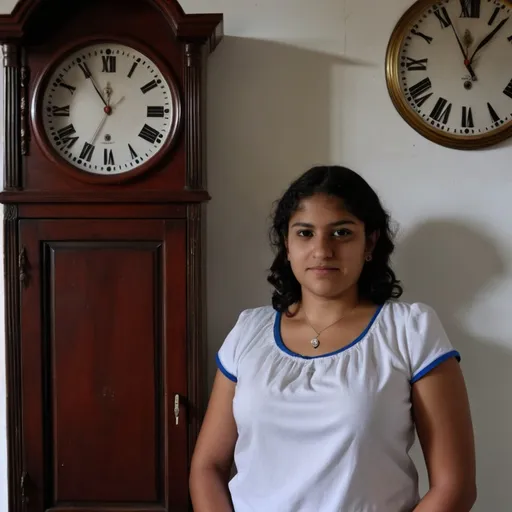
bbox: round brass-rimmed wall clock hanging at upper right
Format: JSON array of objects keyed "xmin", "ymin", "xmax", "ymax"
[{"xmin": 386, "ymin": 0, "xmax": 512, "ymax": 149}]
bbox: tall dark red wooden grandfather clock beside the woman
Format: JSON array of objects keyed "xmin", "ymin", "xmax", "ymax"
[{"xmin": 0, "ymin": 0, "xmax": 222, "ymax": 512}]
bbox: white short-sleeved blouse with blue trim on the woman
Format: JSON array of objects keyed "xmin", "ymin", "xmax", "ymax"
[{"xmin": 217, "ymin": 301, "xmax": 460, "ymax": 512}]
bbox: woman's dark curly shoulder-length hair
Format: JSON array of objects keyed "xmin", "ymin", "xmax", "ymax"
[{"xmin": 267, "ymin": 166, "xmax": 403, "ymax": 312}]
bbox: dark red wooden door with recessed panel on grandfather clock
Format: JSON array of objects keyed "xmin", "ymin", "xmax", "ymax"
[{"xmin": 20, "ymin": 219, "xmax": 188, "ymax": 512}]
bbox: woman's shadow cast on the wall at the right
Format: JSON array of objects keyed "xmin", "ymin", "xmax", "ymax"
[{"xmin": 396, "ymin": 220, "xmax": 512, "ymax": 512}]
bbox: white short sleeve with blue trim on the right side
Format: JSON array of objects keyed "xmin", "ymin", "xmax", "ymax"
[{"xmin": 407, "ymin": 303, "xmax": 461, "ymax": 384}]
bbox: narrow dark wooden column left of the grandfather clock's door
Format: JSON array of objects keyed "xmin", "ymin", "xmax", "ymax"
[{"xmin": 4, "ymin": 204, "xmax": 24, "ymax": 512}]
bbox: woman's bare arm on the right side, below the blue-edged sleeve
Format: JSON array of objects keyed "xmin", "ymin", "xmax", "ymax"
[{"xmin": 412, "ymin": 359, "xmax": 476, "ymax": 512}]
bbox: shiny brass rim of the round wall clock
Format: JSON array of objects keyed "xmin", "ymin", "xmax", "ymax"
[{"xmin": 385, "ymin": 0, "xmax": 512, "ymax": 150}]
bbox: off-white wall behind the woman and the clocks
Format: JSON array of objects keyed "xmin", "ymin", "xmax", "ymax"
[{"xmin": 0, "ymin": 0, "xmax": 512, "ymax": 512}]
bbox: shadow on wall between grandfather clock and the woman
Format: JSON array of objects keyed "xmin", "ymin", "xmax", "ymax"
[{"xmin": 207, "ymin": 37, "xmax": 373, "ymax": 388}]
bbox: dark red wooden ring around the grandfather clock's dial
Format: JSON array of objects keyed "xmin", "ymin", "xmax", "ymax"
[{"xmin": 30, "ymin": 34, "xmax": 183, "ymax": 185}]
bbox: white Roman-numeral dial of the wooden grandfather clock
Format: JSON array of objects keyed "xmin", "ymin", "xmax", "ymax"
[{"xmin": 41, "ymin": 43, "xmax": 178, "ymax": 175}]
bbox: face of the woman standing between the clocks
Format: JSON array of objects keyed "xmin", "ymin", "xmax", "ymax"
[{"xmin": 287, "ymin": 194, "xmax": 372, "ymax": 299}]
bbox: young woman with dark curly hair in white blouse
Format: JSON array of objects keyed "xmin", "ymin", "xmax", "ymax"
[{"xmin": 190, "ymin": 167, "xmax": 476, "ymax": 512}]
